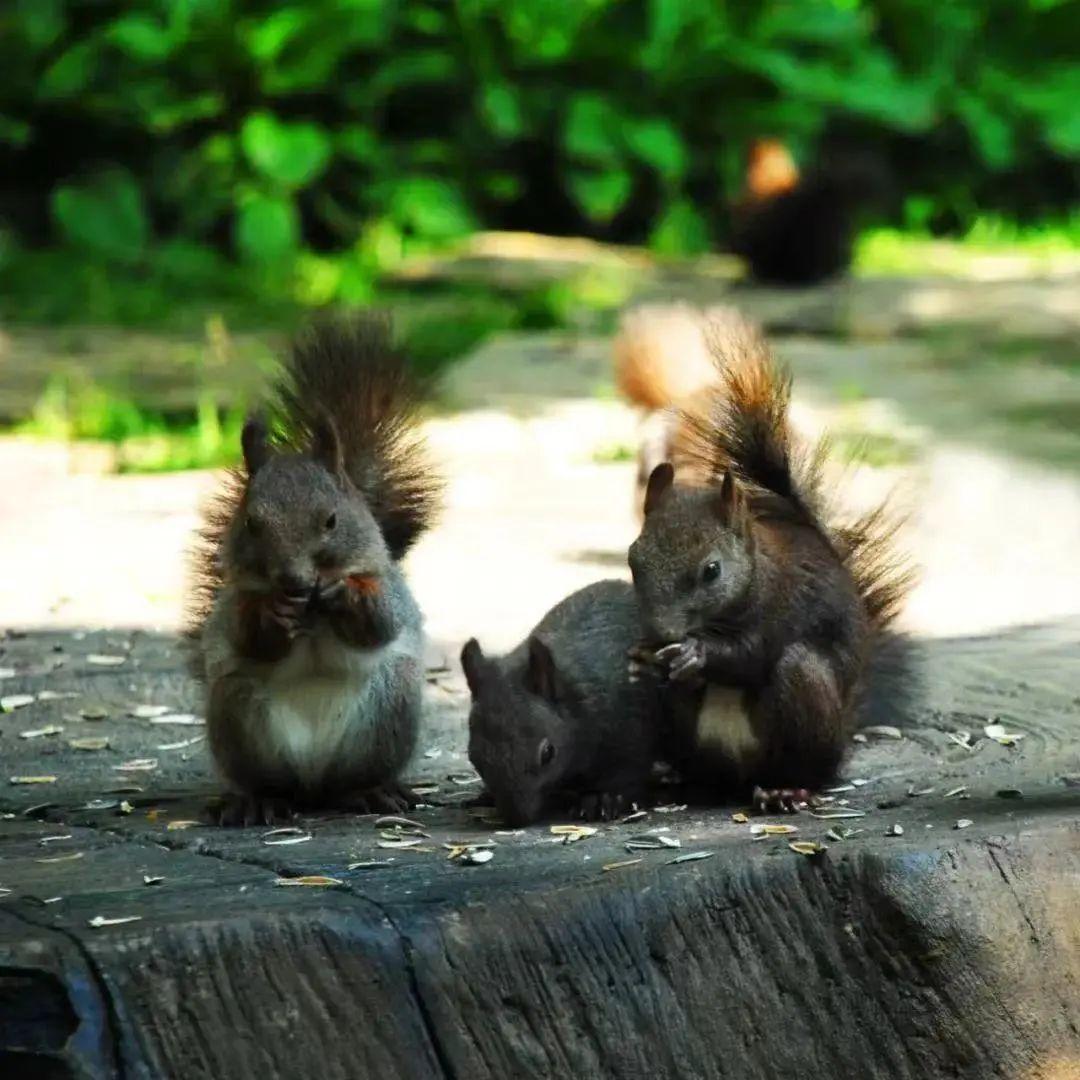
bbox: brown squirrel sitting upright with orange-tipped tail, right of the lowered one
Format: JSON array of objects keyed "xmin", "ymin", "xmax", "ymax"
[{"xmin": 630, "ymin": 320, "xmax": 912, "ymax": 809}]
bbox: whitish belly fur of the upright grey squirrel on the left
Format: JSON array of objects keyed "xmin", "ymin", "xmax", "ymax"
[{"xmin": 264, "ymin": 634, "xmax": 396, "ymax": 784}]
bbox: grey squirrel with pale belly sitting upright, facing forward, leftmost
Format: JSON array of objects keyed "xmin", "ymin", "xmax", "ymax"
[{"xmin": 189, "ymin": 315, "xmax": 440, "ymax": 823}]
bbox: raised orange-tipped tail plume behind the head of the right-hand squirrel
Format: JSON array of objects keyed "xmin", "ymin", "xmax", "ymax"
[{"xmin": 676, "ymin": 313, "xmax": 824, "ymax": 524}]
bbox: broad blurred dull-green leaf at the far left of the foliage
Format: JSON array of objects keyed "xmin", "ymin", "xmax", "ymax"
[{"xmin": 53, "ymin": 170, "xmax": 149, "ymax": 262}]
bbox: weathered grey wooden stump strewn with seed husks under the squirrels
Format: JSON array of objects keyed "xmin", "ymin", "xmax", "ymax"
[{"xmin": 0, "ymin": 622, "xmax": 1080, "ymax": 1080}]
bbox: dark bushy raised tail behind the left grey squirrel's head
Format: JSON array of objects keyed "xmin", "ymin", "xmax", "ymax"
[{"xmin": 275, "ymin": 314, "xmax": 442, "ymax": 558}]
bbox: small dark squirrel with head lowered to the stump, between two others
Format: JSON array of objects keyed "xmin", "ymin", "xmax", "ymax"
[{"xmin": 461, "ymin": 581, "xmax": 659, "ymax": 825}]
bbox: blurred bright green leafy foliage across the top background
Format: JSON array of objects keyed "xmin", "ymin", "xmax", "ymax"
[{"xmin": 0, "ymin": 0, "xmax": 1080, "ymax": 318}]
